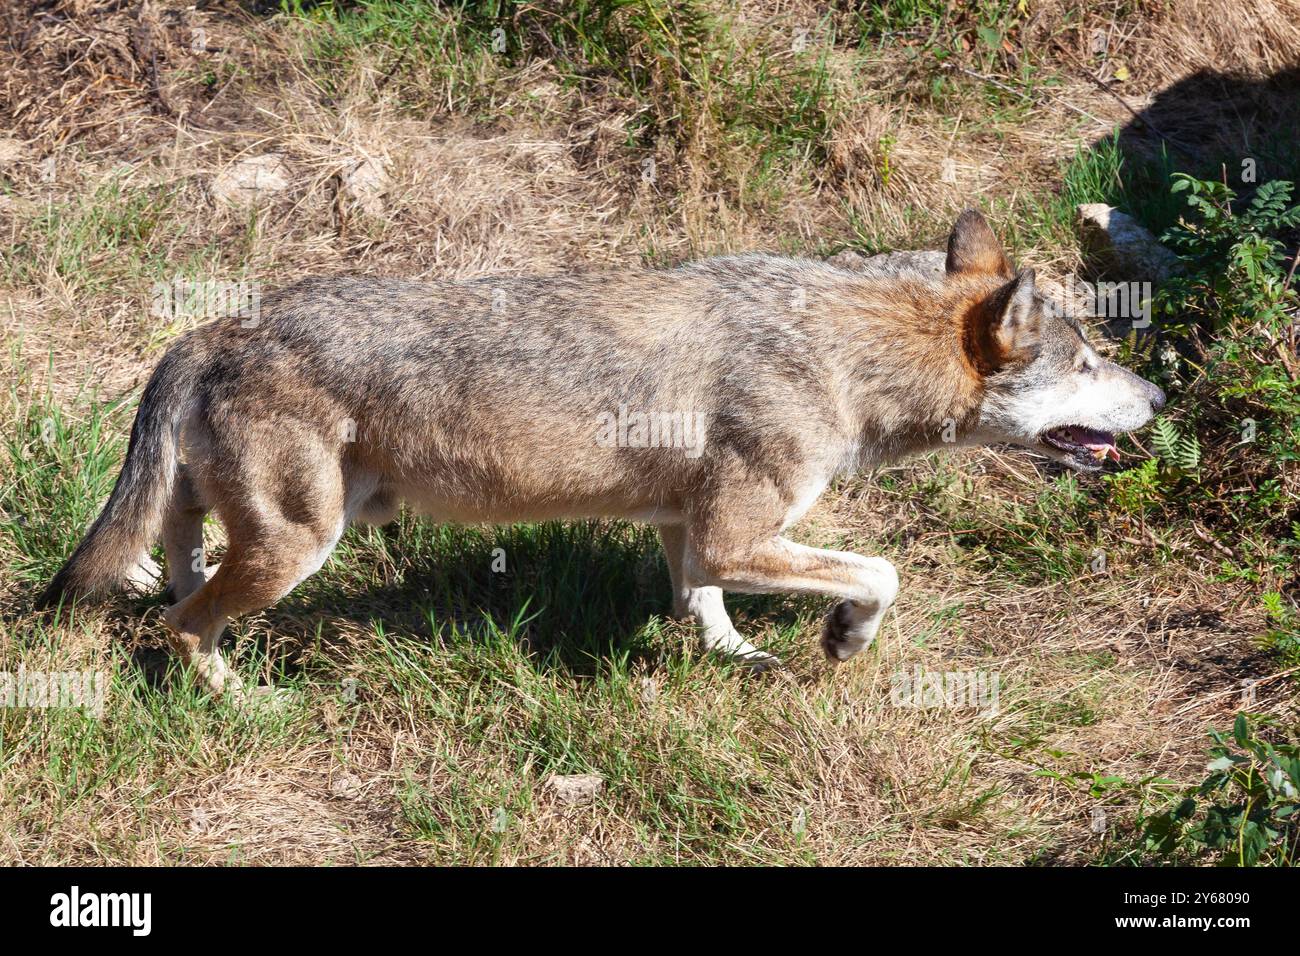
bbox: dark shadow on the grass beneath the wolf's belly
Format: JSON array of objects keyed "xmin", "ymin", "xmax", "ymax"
[{"xmin": 189, "ymin": 516, "xmax": 824, "ymax": 676}]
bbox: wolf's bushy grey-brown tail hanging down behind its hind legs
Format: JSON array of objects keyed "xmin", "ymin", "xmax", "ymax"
[{"xmin": 38, "ymin": 342, "xmax": 192, "ymax": 607}]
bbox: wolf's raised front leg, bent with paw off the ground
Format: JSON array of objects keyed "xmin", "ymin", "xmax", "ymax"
[{"xmin": 685, "ymin": 522, "xmax": 898, "ymax": 661}]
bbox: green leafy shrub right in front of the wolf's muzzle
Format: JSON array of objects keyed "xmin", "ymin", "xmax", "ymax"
[{"xmin": 1109, "ymin": 173, "xmax": 1300, "ymax": 576}]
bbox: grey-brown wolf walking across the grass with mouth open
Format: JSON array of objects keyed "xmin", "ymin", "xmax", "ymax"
[{"xmin": 42, "ymin": 212, "xmax": 1165, "ymax": 692}]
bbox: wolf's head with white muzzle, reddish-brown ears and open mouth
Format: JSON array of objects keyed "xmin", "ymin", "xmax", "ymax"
[{"xmin": 946, "ymin": 211, "xmax": 1165, "ymax": 471}]
